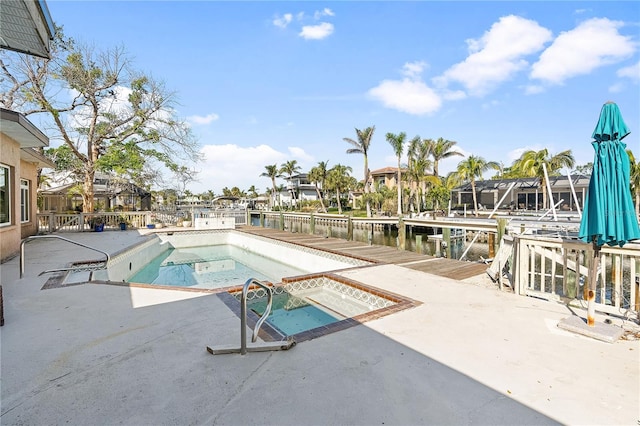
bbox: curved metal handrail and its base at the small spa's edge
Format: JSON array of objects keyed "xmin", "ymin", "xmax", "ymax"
[{"xmin": 207, "ymin": 278, "xmax": 296, "ymax": 355}]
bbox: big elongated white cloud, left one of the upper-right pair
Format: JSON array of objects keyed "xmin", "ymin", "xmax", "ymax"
[{"xmin": 434, "ymin": 15, "xmax": 551, "ymax": 96}]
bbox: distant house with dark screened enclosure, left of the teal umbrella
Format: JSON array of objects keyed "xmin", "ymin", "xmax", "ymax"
[{"xmin": 451, "ymin": 175, "xmax": 589, "ymax": 211}]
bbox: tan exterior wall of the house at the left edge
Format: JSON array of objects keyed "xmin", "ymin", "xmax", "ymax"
[{"xmin": 0, "ymin": 133, "xmax": 38, "ymax": 261}]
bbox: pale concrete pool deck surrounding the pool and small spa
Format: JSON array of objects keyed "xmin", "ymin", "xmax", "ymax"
[{"xmin": 0, "ymin": 230, "xmax": 640, "ymax": 425}]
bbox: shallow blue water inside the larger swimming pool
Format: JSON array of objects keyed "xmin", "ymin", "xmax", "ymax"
[{"xmin": 128, "ymin": 244, "xmax": 308, "ymax": 289}]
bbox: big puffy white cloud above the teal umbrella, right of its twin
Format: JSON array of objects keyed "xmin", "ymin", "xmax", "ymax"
[{"xmin": 531, "ymin": 18, "xmax": 637, "ymax": 84}]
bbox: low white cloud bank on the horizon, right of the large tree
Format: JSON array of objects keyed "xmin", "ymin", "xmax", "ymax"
[{"xmin": 194, "ymin": 144, "xmax": 314, "ymax": 194}]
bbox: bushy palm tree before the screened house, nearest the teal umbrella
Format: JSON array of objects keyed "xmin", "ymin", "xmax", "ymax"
[{"xmin": 512, "ymin": 148, "xmax": 575, "ymax": 208}]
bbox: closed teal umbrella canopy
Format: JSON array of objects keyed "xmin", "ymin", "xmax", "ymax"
[{"xmin": 578, "ymin": 102, "xmax": 640, "ymax": 247}]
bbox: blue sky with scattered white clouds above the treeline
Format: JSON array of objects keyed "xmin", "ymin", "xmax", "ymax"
[{"xmin": 47, "ymin": 0, "xmax": 640, "ymax": 194}]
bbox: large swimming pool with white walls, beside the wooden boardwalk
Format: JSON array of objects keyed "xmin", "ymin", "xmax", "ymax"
[{"xmin": 94, "ymin": 230, "xmax": 371, "ymax": 289}]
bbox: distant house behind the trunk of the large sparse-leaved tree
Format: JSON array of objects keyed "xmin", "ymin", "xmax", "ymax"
[{"xmin": 40, "ymin": 173, "xmax": 151, "ymax": 213}]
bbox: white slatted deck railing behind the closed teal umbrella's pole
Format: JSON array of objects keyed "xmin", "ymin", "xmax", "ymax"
[{"xmin": 511, "ymin": 235, "xmax": 640, "ymax": 319}]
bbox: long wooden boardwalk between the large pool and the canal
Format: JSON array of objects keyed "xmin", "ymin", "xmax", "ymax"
[{"xmin": 238, "ymin": 226, "xmax": 488, "ymax": 280}]
